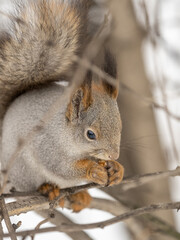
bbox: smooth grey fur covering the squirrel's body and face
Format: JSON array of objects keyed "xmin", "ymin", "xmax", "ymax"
[{"xmin": 1, "ymin": 84, "xmax": 121, "ymax": 191}]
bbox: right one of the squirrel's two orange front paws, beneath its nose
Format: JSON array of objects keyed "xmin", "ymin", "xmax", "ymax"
[{"xmin": 99, "ymin": 160, "xmax": 124, "ymax": 186}]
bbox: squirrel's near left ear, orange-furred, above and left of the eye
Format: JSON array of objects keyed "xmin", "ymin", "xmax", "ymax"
[{"xmin": 66, "ymin": 78, "xmax": 92, "ymax": 123}]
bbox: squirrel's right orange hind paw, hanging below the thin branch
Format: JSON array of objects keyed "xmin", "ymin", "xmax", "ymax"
[{"xmin": 68, "ymin": 191, "xmax": 92, "ymax": 212}]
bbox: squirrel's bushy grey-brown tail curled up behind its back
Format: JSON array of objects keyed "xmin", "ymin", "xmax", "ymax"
[{"xmin": 0, "ymin": 0, "xmax": 90, "ymax": 117}]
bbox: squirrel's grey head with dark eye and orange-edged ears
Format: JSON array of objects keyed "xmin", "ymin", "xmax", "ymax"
[{"xmin": 66, "ymin": 81, "xmax": 122, "ymax": 160}]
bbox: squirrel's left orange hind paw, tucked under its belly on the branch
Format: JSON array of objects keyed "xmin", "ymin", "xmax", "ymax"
[{"xmin": 38, "ymin": 183, "xmax": 64, "ymax": 207}]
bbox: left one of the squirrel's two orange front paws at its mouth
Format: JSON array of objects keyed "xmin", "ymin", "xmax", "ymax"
[{"xmin": 86, "ymin": 162, "xmax": 108, "ymax": 185}]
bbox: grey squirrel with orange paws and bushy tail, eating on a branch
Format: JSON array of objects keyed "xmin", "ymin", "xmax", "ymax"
[{"xmin": 0, "ymin": 0, "xmax": 124, "ymax": 212}]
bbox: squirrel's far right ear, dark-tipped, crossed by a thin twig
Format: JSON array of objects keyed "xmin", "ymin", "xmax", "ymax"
[{"xmin": 103, "ymin": 50, "xmax": 119, "ymax": 99}]
